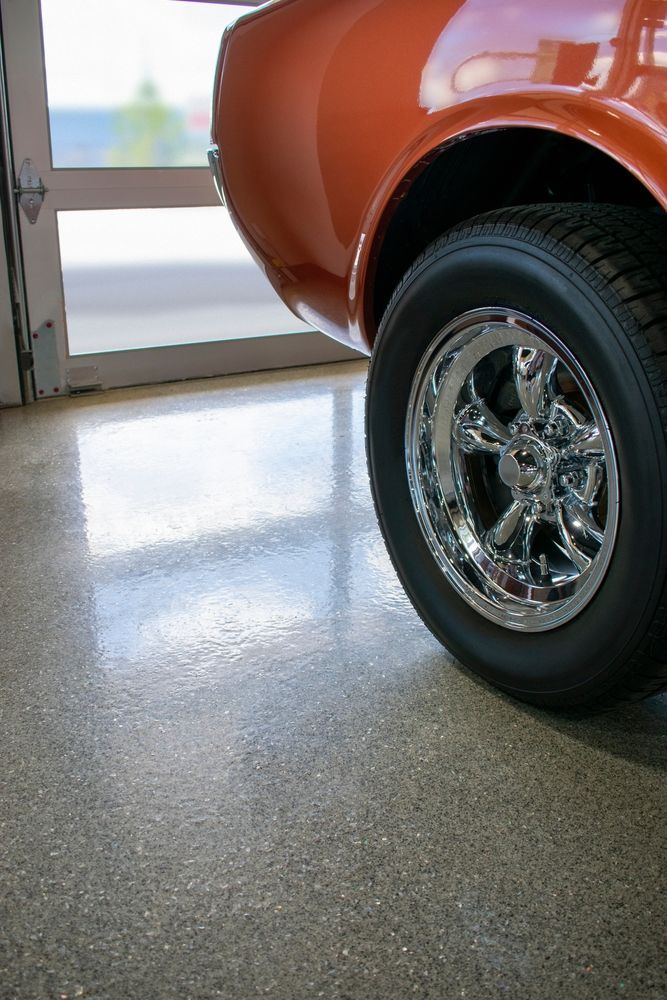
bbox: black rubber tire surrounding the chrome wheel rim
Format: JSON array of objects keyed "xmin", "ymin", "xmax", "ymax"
[{"xmin": 366, "ymin": 204, "xmax": 667, "ymax": 708}]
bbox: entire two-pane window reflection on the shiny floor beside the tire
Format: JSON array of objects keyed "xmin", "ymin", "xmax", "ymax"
[{"xmin": 77, "ymin": 372, "xmax": 406, "ymax": 685}]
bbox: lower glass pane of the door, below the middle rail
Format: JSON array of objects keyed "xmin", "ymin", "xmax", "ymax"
[{"xmin": 58, "ymin": 207, "xmax": 310, "ymax": 354}]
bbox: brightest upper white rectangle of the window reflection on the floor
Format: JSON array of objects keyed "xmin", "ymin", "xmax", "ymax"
[{"xmin": 77, "ymin": 390, "xmax": 333, "ymax": 559}]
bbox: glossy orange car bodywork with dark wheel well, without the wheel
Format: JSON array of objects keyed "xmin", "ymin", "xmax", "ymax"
[{"xmin": 212, "ymin": 0, "xmax": 667, "ymax": 351}]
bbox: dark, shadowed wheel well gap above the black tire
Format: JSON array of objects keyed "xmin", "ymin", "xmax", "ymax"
[{"xmin": 368, "ymin": 128, "xmax": 662, "ymax": 330}]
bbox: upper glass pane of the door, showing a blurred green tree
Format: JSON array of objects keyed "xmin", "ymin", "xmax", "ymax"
[{"xmin": 42, "ymin": 0, "xmax": 252, "ymax": 167}]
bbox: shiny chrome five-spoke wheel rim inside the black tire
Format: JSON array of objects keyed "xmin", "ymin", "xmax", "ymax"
[{"xmin": 405, "ymin": 308, "xmax": 619, "ymax": 631}]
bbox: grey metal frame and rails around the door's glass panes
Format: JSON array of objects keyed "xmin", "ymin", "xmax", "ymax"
[{"xmin": 0, "ymin": 0, "xmax": 360, "ymax": 397}]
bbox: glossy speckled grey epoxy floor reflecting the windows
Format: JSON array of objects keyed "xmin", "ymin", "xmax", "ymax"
[{"xmin": 0, "ymin": 363, "xmax": 667, "ymax": 1000}]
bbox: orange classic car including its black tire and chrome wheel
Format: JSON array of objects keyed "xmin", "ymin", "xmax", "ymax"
[{"xmin": 209, "ymin": 0, "xmax": 667, "ymax": 707}]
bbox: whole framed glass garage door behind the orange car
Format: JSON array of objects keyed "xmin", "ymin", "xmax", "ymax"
[{"xmin": 0, "ymin": 0, "xmax": 355, "ymax": 397}]
